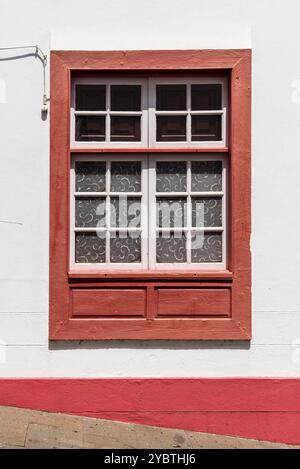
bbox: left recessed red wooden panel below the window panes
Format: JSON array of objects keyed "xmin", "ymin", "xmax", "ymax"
[{"xmin": 71, "ymin": 288, "xmax": 146, "ymax": 317}]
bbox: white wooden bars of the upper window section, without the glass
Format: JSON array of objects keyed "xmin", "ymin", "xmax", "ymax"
[{"xmin": 70, "ymin": 76, "xmax": 228, "ymax": 150}]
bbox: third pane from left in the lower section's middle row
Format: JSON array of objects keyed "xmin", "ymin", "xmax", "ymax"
[{"xmin": 156, "ymin": 197, "xmax": 186, "ymax": 228}]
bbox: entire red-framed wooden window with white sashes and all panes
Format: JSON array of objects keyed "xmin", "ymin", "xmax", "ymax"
[{"xmin": 50, "ymin": 50, "xmax": 251, "ymax": 340}]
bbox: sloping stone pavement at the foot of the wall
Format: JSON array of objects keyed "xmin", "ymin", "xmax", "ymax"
[{"xmin": 0, "ymin": 407, "xmax": 296, "ymax": 449}]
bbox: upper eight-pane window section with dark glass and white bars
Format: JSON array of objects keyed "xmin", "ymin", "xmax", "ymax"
[{"xmin": 70, "ymin": 76, "xmax": 228, "ymax": 149}]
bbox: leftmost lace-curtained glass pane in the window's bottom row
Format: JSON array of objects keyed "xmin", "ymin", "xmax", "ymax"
[{"xmin": 75, "ymin": 232, "xmax": 106, "ymax": 263}]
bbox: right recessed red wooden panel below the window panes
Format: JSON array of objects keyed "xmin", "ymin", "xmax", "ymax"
[{"xmin": 157, "ymin": 288, "xmax": 230, "ymax": 316}]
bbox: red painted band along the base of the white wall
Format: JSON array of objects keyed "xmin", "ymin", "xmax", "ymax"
[{"xmin": 0, "ymin": 378, "xmax": 300, "ymax": 444}]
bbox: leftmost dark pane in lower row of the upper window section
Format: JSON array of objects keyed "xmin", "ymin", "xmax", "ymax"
[{"xmin": 75, "ymin": 116, "xmax": 105, "ymax": 142}]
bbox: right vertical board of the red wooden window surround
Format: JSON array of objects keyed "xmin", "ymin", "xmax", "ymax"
[{"xmin": 229, "ymin": 52, "xmax": 251, "ymax": 335}]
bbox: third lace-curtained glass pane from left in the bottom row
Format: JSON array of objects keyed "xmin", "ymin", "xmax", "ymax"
[{"xmin": 156, "ymin": 232, "xmax": 186, "ymax": 264}]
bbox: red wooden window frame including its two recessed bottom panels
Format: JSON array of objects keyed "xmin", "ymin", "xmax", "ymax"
[{"xmin": 50, "ymin": 49, "xmax": 251, "ymax": 340}]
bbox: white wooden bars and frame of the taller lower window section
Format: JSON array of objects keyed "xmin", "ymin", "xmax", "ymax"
[{"xmin": 70, "ymin": 153, "xmax": 228, "ymax": 273}]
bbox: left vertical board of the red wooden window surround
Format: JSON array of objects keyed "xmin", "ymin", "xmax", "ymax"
[{"xmin": 49, "ymin": 53, "xmax": 70, "ymax": 338}]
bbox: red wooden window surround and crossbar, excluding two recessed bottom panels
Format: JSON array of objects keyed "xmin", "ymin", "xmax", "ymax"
[{"xmin": 50, "ymin": 50, "xmax": 251, "ymax": 340}]
